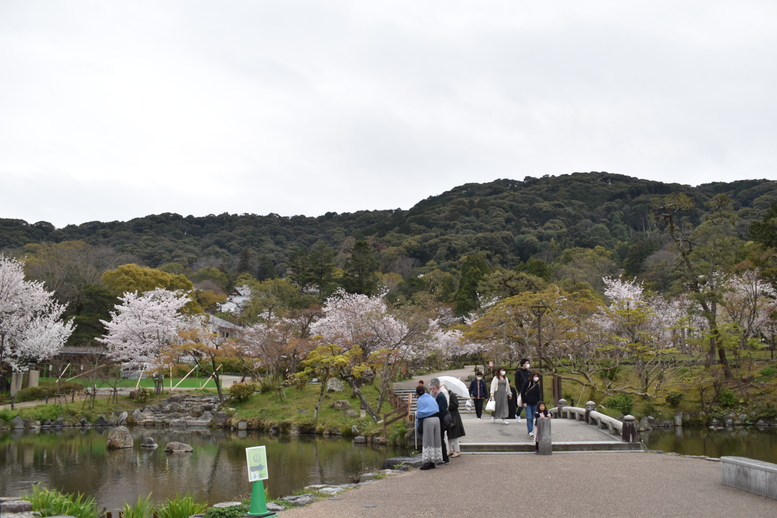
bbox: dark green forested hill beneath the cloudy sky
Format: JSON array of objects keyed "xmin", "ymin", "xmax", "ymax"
[{"xmin": 0, "ymin": 172, "xmax": 777, "ymax": 277}]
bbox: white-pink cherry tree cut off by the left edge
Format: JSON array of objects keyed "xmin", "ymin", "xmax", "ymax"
[{"xmin": 0, "ymin": 254, "xmax": 73, "ymax": 390}]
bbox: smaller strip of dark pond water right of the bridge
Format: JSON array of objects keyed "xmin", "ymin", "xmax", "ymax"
[{"xmin": 640, "ymin": 426, "xmax": 777, "ymax": 463}]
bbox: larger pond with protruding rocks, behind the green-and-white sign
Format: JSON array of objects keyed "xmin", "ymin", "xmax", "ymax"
[{"xmin": 0, "ymin": 428, "xmax": 409, "ymax": 510}]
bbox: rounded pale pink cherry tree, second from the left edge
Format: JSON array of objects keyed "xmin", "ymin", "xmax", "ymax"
[{"xmin": 97, "ymin": 288, "xmax": 198, "ymax": 365}]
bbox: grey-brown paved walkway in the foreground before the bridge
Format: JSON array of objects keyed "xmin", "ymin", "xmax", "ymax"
[{"xmin": 279, "ymin": 453, "xmax": 777, "ymax": 518}]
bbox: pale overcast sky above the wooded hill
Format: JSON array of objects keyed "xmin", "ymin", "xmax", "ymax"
[{"xmin": 0, "ymin": 0, "xmax": 777, "ymax": 227}]
